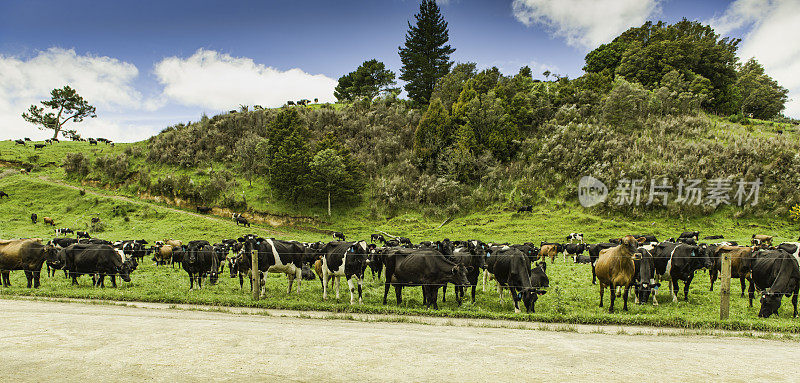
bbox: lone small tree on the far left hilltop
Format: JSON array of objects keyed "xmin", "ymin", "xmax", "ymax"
[{"xmin": 22, "ymin": 85, "xmax": 97, "ymax": 138}]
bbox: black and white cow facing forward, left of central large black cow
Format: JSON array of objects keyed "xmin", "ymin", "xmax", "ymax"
[{"xmin": 320, "ymin": 241, "xmax": 369, "ymax": 304}]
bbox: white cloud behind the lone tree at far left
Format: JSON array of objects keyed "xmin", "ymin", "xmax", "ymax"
[{"xmin": 0, "ymin": 48, "xmax": 156, "ymax": 139}]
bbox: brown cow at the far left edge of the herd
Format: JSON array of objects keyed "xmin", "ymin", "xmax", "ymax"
[{"xmin": 0, "ymin": 238, "xmax": 56, "ymax": 289}]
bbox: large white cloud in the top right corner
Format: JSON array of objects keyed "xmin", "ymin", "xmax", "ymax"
[{"xmin": 709, "ymin": 0, "xmax": 800, "ymax": 118}]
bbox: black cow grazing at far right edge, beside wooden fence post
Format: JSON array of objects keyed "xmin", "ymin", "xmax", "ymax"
[{"xmin": 752, "ymin": 248, "xmax": 800, "ymax": 318}]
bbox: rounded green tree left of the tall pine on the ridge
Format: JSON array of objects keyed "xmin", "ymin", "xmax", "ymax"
[{"xmin": 333, "ymin": 59, "xmax": 400, "ymax": 101}]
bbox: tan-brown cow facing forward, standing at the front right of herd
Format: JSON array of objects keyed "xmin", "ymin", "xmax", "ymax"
[{"xmin": 595, "ymin": 235, "xmax": 639, "ymax": 312}]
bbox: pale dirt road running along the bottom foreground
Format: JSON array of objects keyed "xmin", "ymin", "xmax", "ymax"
[{"xmin": 0, "ymin": 300, "xmax": 800, "ymax": 382}]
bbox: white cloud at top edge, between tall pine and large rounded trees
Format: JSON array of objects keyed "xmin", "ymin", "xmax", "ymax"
[{"xmin": 511, "ymin": 0, "xmax": 659, "ymax": 50}]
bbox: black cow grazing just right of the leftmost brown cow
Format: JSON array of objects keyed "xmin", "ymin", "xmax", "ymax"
[{"xmin": 61, "ymin": 243, "xmax": 134, "ymax": 287}]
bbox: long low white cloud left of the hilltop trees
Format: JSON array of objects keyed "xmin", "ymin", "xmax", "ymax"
[{"xmin": 155, "ymin": 49, "xmax": 336, "ymax": 110}]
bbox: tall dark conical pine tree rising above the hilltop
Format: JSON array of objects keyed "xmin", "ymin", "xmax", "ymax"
[{"xmin": 398, "ymin": 0, "xmax": 455, "ymax": 105}]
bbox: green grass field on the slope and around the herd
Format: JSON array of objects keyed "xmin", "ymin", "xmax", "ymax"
[{"xmin": 0, "ymin": 143, "xmax": 800, "ymax": 333}]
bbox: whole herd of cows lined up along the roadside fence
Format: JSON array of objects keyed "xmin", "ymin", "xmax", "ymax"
[{"xmin": 0, "ymin": 231, "xmax": 800, "ymax": 317}]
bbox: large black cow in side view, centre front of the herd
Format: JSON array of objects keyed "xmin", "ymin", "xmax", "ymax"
[{"xmin": 383, "ymin": 249, "xmax": 469, "ymax": 310}]
